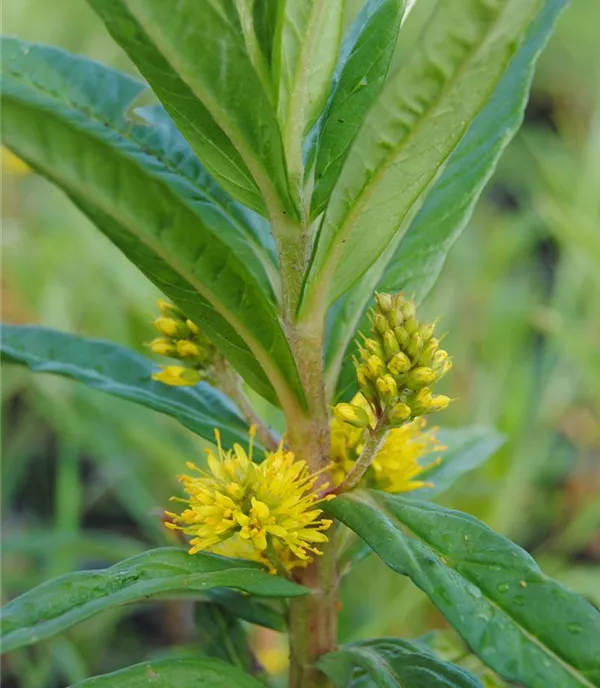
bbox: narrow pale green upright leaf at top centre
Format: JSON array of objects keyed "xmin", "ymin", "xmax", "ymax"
[{"xmin": 273, "ymin": 0, "xmax": 344, "ymax": 197}]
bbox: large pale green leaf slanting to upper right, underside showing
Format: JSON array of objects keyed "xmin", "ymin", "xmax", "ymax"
[{"xmin": 302, "ymin": 0, "xmax": 556, "ymax": 310}]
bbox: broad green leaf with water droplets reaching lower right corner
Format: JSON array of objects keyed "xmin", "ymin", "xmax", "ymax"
[{"xmin": 325, "ymin": 490, "xmax": 600, "ymax": 688}]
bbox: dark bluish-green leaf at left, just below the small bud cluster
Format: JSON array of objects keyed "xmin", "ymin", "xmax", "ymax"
[{"xmin": 0, "ymin": 324, "xmax": 253, "ymax": 446}]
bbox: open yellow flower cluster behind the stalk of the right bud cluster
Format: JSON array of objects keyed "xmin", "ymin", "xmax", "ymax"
[{"xmin": 331, "ymin": 393, "xmax": 446, "ymax": 494}]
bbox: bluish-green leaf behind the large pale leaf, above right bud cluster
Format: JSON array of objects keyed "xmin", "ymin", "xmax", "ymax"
[{"xmin": 326, "ymin": 0, "xmax": 568, "ymax": 398}]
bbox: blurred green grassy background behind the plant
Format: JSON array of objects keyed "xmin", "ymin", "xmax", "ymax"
[{"xmin": 0, "ymin": 0, "xmax": 600, "ymax": 688}]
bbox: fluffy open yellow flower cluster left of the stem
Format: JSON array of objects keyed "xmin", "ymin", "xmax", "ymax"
[{"xmin": 167, "ymin": 428, "xmax": 332, "ymax": 573}]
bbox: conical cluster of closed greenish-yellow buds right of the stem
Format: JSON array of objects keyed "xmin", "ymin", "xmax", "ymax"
[{"xmin": 335, "ymin": 294, "xmax": 452, "ymax": 428}]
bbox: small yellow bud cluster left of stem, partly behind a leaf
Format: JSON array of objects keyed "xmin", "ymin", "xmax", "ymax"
[{"xmin": 149, "ymin": 299, "xmax": 216, "ymax": 387}]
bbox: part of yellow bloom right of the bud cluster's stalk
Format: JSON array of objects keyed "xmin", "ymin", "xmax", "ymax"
[{"xmin": 371, "ymin": 417, "xmax": 446, "ymax": 493}]
